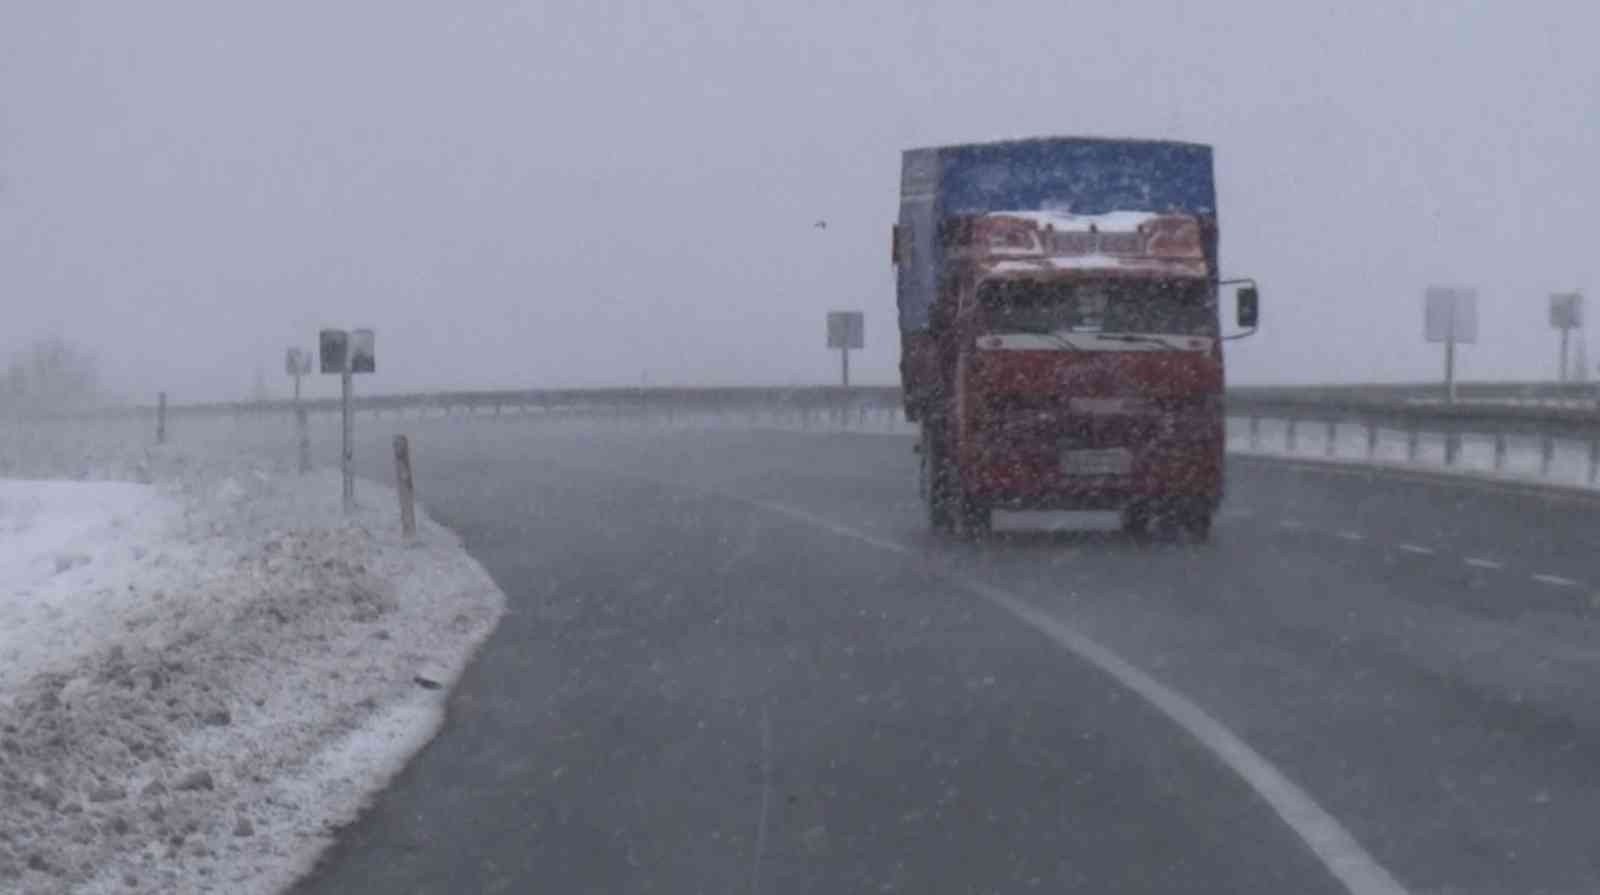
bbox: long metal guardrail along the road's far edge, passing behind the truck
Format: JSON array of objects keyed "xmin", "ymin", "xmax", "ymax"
[{"xmin": 12, "ymin": 383, "xmax": 1600, "ymax": 485}]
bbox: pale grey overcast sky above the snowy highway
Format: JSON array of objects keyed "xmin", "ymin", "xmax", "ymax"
[{"xmin": 0, "ymin": 0, "xmax": 1600, "ymax": 397}]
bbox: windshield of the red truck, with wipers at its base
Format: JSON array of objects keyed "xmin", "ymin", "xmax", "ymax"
[{"xmin": 978, "ymin": 280, "xmax": 1218, "ymax": 336}]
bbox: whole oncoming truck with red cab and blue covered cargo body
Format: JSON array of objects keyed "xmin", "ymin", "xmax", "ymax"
[{"xmin": 891, "ymin": 136, "xmax": 1259, "ymax": 540}]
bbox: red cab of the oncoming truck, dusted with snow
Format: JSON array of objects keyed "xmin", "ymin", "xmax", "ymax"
[{"xmin": 920, "ymin": 197, "xmax": 1254, "ymax": 538}]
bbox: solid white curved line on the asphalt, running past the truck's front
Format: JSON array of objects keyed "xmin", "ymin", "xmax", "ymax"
[{"xmin": 732, "ymin": 492, "xmax": 1406, "ymax": 895}]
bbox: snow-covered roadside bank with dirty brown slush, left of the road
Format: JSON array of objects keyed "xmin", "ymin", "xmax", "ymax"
[{"xmin": 0, "ymin": 452, "xmax": 504, "ymax": 893}]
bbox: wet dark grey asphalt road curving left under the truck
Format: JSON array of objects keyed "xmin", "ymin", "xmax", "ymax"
[{"xmin": 299, "ymin": 419, "xmax": 1600, "ymax": 893}]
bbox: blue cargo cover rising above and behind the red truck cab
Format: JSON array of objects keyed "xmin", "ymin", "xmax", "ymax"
[{"xmin": 896, "ymin": 136, "xmax": 1216, "ymax": 333}]
